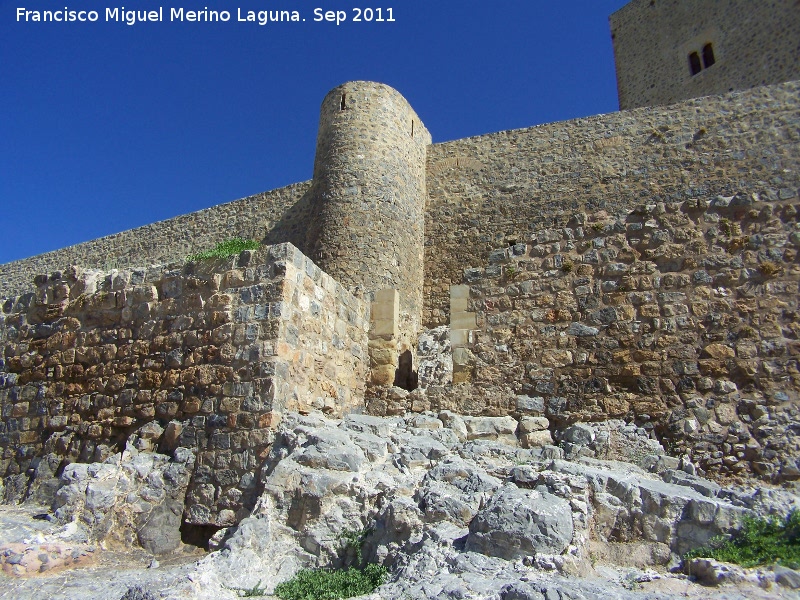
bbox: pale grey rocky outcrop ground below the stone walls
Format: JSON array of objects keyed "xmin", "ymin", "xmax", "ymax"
[{"xmin": 0, "ymin": 411, "xmax": 800, "ymax": 600}]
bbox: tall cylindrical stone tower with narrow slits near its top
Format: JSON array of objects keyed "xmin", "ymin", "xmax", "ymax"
[{"xmin": 306, "ymin": 81, "xmax": 431, "ymax": 358}]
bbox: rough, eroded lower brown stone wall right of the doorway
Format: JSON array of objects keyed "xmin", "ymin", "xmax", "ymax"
[{"xmin": 428, "ymin": 193, "xmax": 800, "ymax": 481}]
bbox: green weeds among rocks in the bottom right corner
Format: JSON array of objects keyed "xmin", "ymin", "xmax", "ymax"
[{"xmin": 684, "ymin": 511, "xmax": 800, "ymax": 569}]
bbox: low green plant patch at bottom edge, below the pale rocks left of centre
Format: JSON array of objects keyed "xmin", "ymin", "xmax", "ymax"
[{"xmin": 275, "ymin": 564, "xmax": 386, "ymax": 600}]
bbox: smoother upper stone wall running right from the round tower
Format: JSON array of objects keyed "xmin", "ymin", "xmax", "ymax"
[{"xmin": 424, "ymin": 83, "xmax": 800, "ymax": 327}]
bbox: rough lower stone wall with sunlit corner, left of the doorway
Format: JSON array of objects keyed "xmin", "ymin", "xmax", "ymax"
[{"xmin": 0, "ymin": 244, "xmax": 369, "ymax": 526}]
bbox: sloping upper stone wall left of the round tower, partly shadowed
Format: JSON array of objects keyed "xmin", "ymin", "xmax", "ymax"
[{"xmin": 0, "ymin": 182, "xmax": 311, "ymax": 297}]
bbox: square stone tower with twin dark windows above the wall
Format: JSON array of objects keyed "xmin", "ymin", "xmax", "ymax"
[{"xmin": 610, "ymin": 0, "xmax": 800, "ymax": 110}]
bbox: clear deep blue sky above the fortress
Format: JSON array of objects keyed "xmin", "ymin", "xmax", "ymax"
[{"xmin": 0, "ymin": 0, "xmax": 626, "ymax": 263}]
